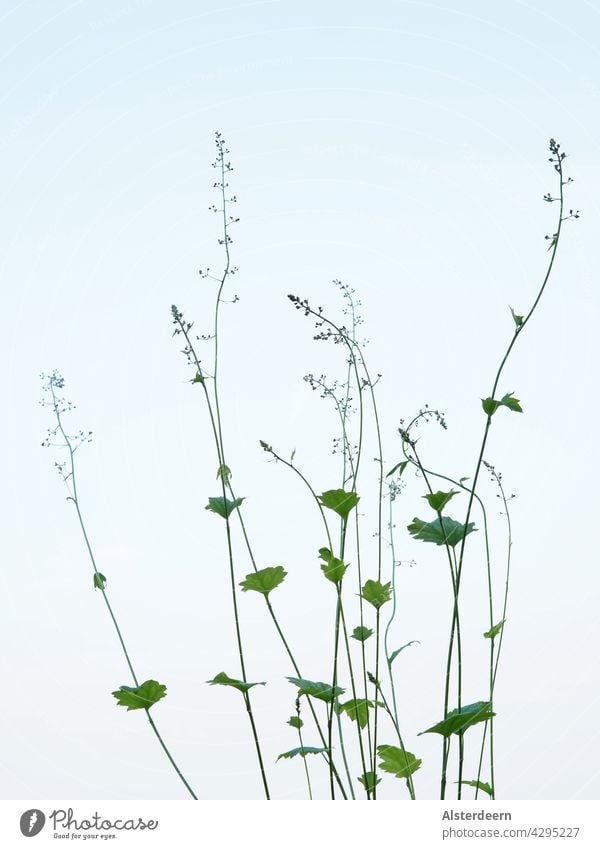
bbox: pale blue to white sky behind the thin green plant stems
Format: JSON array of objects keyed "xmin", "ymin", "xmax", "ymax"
[{"xmin": 0, "ymin": 0, "xmax": 600, "ymax": 799}]
